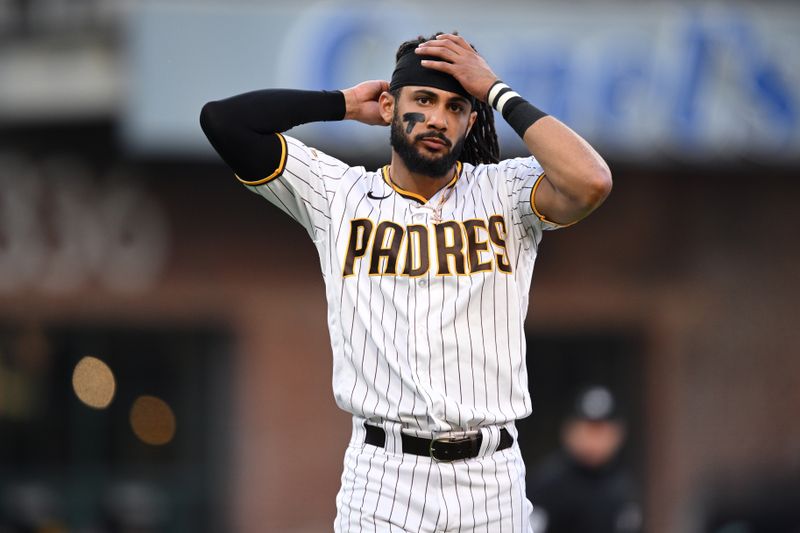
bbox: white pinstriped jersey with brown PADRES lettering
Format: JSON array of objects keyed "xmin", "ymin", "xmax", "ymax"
[{"xmin": 242, "ymin": 135, "xmax": 558, "ymax": 435}]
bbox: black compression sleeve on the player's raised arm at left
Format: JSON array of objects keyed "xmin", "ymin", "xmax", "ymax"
[{"xmin": 200, "ymin": 89, "xmax": 345, "ymax": 181}]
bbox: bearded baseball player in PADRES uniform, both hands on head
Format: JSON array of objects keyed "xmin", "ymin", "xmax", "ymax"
[{"xmin": 200, "ymin": 33, "xmax": 611, "ymax": 532}]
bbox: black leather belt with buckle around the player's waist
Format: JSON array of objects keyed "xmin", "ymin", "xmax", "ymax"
[{"xmin": 364, "ymin": 423, "xmax": 514, "ymax": 461}]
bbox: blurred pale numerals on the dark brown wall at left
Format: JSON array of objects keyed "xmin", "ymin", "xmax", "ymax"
[{"xmin": 0, "ymin": 154, "xmax": 168, "ymax": 294}]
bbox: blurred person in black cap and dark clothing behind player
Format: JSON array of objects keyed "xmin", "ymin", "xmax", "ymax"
[{"xmin": 528, "ymin": 386, "xmax": 642, "ymax": 533}]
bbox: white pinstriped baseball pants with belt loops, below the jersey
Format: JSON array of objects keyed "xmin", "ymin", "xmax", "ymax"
[{"xmin": 334, "ymin": 417, "xmax": 532, "ymax": 533}]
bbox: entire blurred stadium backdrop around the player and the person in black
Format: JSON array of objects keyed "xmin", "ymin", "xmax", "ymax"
[{"xmin": 0, "ymin": 0, "xmax": 800, "ymax": 533}]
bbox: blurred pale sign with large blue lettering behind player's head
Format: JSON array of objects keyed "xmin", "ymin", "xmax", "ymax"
[{"xmin": 123, "ymin": 1, "xmax": 800, "ymax": 162}]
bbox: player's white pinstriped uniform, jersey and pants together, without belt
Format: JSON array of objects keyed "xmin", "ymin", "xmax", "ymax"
[{"xmin": 244, "ymin": 136, "xmax": 556, "ymax": 532}]
